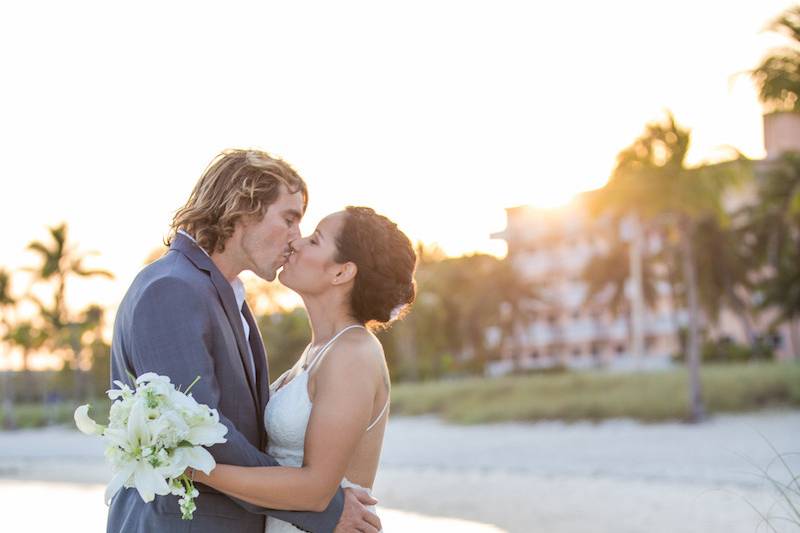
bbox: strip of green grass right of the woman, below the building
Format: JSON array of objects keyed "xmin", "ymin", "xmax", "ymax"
[{"xmin": 392, "ymin": 363, "xmax": 800, "ymax": 424}]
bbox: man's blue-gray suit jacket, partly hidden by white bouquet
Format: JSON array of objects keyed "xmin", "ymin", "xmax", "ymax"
[{"xmin": 107, "ymin": 234, "xmax": 344, "ymax": 533}]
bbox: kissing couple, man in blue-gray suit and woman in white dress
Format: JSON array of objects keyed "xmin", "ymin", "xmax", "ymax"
[{"xmin": 107, "ymin": 150, "xmax": 416, "ymax": 533}]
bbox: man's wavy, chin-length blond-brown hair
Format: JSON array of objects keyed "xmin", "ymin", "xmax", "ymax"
[{"xmin": 166, "ymin": 150, "xmax": 308, "ymax": 254}]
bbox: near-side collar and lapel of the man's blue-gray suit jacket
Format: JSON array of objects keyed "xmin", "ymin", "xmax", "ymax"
[{"xmin": 170, "ymin": 233, "xmax": 260, "ymax": 406}]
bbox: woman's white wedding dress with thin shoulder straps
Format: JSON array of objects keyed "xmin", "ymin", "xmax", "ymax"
[{"xmin": 264, "ymin": 325, "xmax": 389, "ymax": 533}]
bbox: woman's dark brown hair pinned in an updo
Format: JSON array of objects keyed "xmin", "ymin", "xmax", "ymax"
[{"xmin": 335, "ymin": 206, "xmax": 417, "ymax": 329}]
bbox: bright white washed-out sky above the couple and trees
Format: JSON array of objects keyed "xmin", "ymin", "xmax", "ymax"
[{"xmin": 0, "ymin": 0, "xmax": 792, "ymax": 316}]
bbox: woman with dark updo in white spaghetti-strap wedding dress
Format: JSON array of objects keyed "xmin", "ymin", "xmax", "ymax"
[{"xmin": 193, "ymin": 207, "xmax": 416, "ymax": 533}]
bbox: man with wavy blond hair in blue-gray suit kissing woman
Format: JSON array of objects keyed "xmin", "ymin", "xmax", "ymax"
[{"xmin": 107, "ymin": 150, "xmax": 380, "ymax": 533}]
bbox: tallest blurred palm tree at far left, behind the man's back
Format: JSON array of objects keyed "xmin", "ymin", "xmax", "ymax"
[{"xmin": 28, "ymin": 223, "xmax": 113, "ymax": 397}]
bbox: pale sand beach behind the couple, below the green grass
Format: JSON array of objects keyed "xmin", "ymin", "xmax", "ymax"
[{"xmin": 0, "ymin": 411, "xmax": 800, "ymax": 533}]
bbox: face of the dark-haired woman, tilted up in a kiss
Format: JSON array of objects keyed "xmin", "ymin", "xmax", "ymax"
[{"xmin": 278, "ymin": 211, "xmax": 346, "ymax": 295}]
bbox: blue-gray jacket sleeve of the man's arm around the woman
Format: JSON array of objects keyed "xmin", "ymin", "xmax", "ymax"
[{"xmin": 131, "ymin": 277, "xmax": 344, "ymax": 533}]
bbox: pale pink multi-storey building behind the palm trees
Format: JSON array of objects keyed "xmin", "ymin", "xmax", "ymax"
[{"xmin": 489, "ymin": 113, "xmax": 800, "ymax": 375}]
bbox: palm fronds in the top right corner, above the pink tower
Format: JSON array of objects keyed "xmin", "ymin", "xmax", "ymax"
[{"xmin": 750, "ymin": 5, "xmax": 800, "ymax": 111}]
